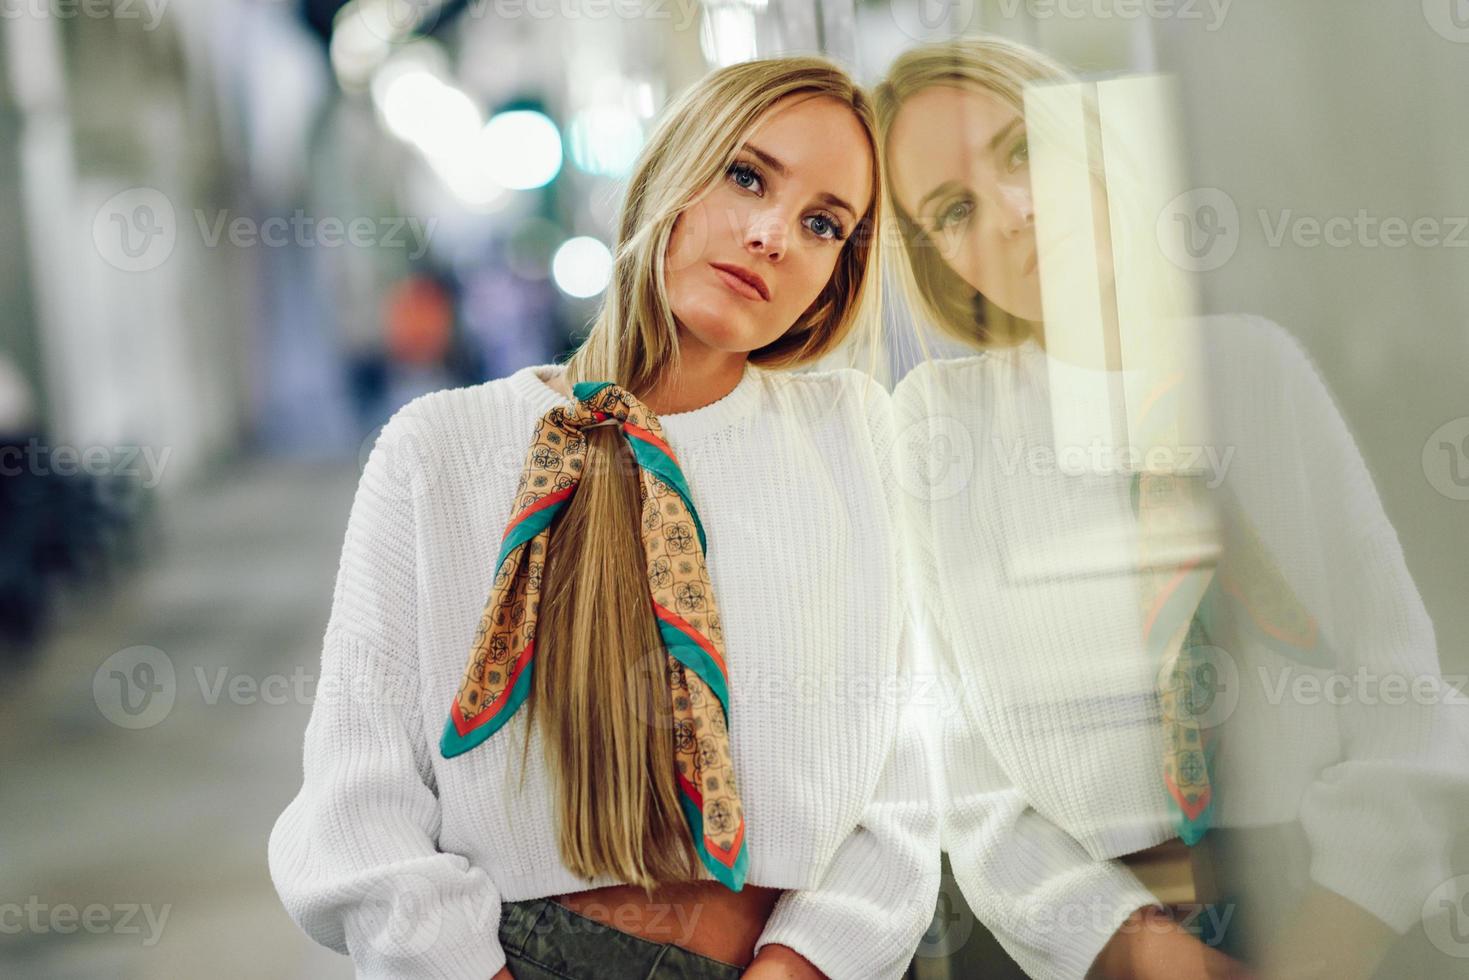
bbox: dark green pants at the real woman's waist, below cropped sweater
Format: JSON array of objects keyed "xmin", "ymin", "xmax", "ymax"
[{"xmin": 499, "ymin": 898, "xmax": 743, "ymax": 980}]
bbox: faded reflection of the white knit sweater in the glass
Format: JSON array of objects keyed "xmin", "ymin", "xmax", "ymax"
[{"xmin": 895, "ymin": 316, "xmax": 1469, "ymax": 977}]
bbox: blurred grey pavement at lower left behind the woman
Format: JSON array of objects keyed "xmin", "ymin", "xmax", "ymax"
[{"xmin": 0, "ymin": 463, "xmax": 357, "ymax": 980}]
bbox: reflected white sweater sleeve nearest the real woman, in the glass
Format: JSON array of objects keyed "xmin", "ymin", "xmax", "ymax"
[{"xmin": 895, "ymin": 367, "xmax": 1162, "ymax": 980}]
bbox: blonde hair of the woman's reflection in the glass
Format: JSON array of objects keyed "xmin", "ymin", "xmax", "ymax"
[{"xmin": 873, "ymin": 35, "xmax": 1078, "ymax": 350}]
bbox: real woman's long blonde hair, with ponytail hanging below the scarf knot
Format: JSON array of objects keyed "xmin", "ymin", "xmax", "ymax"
[{"xmin": 521, "ymin": 56, "xmax": 881, "ymax": 892}]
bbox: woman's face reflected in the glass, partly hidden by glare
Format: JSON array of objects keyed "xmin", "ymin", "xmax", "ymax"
[{"xmin": 887, "ymin": 85, "xmax": 1042, "ymax": 320}]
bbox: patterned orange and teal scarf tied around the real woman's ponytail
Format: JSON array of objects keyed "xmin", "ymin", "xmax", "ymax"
[{"xmin": 439, "ymin": 381, "xmax": 749, "ymax": 892}]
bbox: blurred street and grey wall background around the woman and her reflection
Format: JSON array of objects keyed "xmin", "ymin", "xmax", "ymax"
[{"xmin": 0, "ymin": 0, "xmax": 1469, "ymax": 977}]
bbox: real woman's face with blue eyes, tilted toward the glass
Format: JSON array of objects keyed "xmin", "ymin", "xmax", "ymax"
[{"xmin": 667, "ymin": 96, "xmax": 873, "ymax": 353}]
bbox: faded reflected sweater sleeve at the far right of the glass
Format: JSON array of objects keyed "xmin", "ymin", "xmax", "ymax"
[{"xmin": 1256, "ymin": 317, "xmax": 1469, "ymax": 934}]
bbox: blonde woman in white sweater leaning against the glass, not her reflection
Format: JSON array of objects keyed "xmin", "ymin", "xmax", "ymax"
[{"xmin": 270, "ymin": 57, "xmax": 939, "ymax": 980}]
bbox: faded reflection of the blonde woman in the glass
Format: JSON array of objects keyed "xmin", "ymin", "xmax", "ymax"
[{"xmin": 877, "ymin": 38, "xmax": 1463, "ymax": 977}]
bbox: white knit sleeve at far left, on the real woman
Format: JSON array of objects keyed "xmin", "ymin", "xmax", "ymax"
[{"xmin": 267, "ymin": 403, "xmax": 505, "ymax": 980}]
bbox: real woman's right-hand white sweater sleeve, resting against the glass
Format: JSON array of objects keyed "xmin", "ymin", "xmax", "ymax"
[{"xmin": 755, "ymin": 370, "xmax": 942, "ymax": 980}]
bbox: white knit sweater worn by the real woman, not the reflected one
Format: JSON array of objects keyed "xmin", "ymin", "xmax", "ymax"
[{"xmin": 269, "ymin": 359, "xmax": 939, "ymax": 980}]
